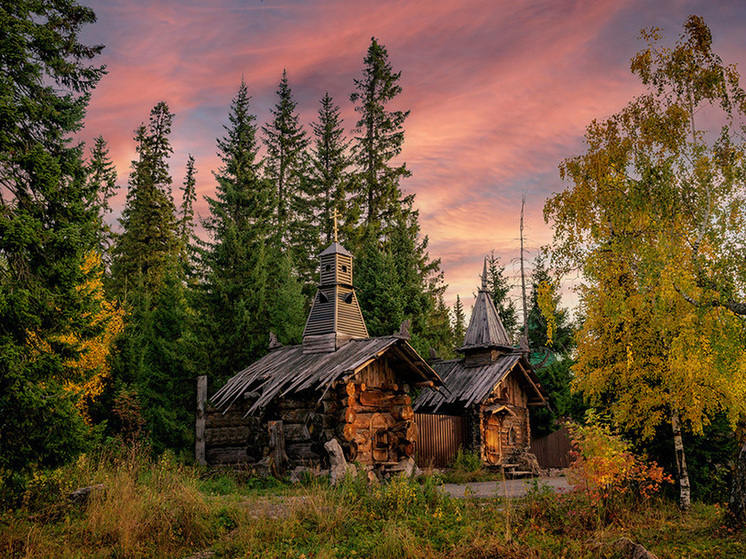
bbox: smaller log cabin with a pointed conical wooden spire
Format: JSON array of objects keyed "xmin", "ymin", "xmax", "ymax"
[{"xmin": 414, "ymin": 261, "xmax": 548, "ymax": 466}]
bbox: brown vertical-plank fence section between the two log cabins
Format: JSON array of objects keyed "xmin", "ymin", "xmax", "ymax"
[{"xmin": 414, "ymin": 413, "xmax": 466, "ymax": 468}]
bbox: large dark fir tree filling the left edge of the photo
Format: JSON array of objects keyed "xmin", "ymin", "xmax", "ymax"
[{"xmin": 0, "ymin": 0, "xmax": 105, "ymax": 487}]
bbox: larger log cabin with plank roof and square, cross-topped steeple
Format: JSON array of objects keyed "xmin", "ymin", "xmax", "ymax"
[{"xmin": 197, "ymin": 235, "xmax": 442, "ymax": 472}]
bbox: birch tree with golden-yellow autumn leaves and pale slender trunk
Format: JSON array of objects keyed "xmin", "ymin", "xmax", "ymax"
[{"xmin": 544, "ymin": 16, "xmax": 746, "ymax": 509}]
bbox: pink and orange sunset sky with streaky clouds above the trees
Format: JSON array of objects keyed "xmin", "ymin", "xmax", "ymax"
[{"xmin": 77, "ymin": 0, "xmax": 746, "ymax": 316}]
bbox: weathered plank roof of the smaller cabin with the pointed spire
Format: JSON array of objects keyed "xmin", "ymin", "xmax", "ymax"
[{"xmin": 414, "ymin": 353, "xmax": 548, "ymax": 413}]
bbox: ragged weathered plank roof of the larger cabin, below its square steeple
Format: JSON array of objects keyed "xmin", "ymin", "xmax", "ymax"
[{"xmin": 211, "ymin": 336, "xmax": 443, "ymax": 414}]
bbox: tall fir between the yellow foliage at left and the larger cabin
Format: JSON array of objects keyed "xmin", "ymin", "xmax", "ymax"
[{"xmin": 107, "ymin": 102, "xmax": 195, "ymax": 451}]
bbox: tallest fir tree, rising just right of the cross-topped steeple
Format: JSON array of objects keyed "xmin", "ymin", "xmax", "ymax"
[{"xmin": 350, "ymin": 38, "xmax": 448, "ymax": 354}]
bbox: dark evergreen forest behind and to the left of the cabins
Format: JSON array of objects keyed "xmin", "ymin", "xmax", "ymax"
[{"xmin": 0, "ymin": 2, "xmax": 560, "ymax": 486}]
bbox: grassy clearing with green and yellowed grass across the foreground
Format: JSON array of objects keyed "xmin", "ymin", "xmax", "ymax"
[{"xmin": 0, "ymin": 455, "xmax": 746, "ymax": 559}]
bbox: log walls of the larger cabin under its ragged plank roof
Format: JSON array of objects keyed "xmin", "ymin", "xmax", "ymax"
[{"xmin": 205, "ymin": 358, "xmax": 418, "ymax": 470}]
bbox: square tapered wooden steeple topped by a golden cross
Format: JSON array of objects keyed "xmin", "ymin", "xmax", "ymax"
[{"xmin": 303, "ymin": 220, "xmax": 368, "ymax": 353}]
